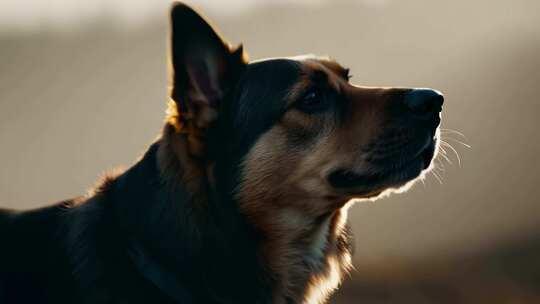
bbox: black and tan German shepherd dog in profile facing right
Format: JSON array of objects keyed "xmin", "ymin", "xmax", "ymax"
[{"xmin": 0, "ymin": 3, "xmax": 443, "ymax": 304}]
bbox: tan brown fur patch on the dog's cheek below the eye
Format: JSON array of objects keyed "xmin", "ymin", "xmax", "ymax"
[{"xmin": 238, "ymin": 113, "xmax": 335, "ymax": 219}]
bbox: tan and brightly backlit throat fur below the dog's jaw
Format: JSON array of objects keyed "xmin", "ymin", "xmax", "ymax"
[{"xmin": 242, "ymin": 207, "xmax": 352, "ymax": 304}]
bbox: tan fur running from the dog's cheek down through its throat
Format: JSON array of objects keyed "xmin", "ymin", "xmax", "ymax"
[{"xmin": 233, "ymin": 121, "xmax": 350, "ymax": 303}]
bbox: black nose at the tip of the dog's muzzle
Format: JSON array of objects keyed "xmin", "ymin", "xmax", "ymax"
[{"xmin": 403, "ymin": 89, "xmax": 444, "ymax": 119}]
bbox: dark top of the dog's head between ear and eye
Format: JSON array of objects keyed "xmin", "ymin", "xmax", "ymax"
[{"xmin": 225, "ymin": 56, "xmax": 345, "ymax": 152}]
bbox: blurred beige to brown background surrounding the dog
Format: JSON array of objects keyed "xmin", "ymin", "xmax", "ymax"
[{"xmin": 0, "ymin": 0, "xmax": 540, "ymax": 303}]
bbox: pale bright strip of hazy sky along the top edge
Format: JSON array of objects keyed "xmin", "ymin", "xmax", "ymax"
[{"xmin": 0, "ymin": 0, "xmax": 390, "ymax": 32}]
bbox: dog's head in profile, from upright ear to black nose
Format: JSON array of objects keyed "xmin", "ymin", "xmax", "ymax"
[{"xmin": 169, "ymin": 4, "xmax": 443, "ymax": 221}]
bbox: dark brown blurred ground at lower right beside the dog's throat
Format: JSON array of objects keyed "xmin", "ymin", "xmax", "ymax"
[{"xmin": 331, "ymin": 235, "xmax": 540, "ymax": 304}]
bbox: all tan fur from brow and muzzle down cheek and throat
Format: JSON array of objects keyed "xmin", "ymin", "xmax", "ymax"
[{"xmin": 237, "ymin": 57, "xmax": 414, "ymax": 303}]
